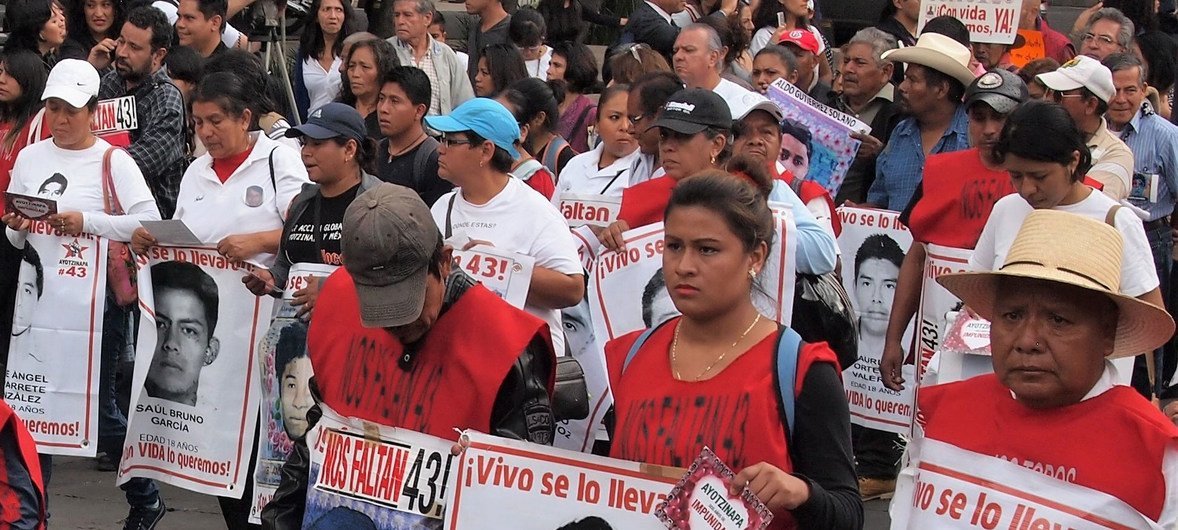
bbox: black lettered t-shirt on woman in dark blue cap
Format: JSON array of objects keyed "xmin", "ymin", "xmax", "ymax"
[{"xmin": 284, "ymin": 184, "xmax": 360, "ymax": 265}]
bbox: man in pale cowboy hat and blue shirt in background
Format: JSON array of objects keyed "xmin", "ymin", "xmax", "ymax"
[{"xmin": 867, "ymin": 33, "xmax": 975, "ymax": 211}]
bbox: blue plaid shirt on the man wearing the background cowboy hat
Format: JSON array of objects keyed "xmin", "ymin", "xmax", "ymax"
[{"xmin": 867, "ymin": 105, "xmax": 969, "ymax": 212}]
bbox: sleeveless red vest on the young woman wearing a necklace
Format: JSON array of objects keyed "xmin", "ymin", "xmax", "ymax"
[{"xmin": 605, "ymin": 319, "xmax": 839, "ymax": 530}]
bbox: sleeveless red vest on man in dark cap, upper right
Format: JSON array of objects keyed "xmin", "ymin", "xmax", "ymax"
[{"xmin": 908, "ymin": 147, "xmax": 1014, "ymax": 249}]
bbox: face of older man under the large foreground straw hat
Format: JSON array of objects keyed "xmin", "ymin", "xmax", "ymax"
[{"xmin": 990, "ymin": 278, "xmax": 1117, "ymax": 409}]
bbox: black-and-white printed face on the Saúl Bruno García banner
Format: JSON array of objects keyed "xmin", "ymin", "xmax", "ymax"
[{"xmin": 147, "ymin": 287, "xmax": 219, "ymax": 398}]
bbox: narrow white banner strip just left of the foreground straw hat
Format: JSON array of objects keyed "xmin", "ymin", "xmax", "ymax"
[{"xmin": 916, "ymin": 244, "xmax": 973, "ymax": 384}]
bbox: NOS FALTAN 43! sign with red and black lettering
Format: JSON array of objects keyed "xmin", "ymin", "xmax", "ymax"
[{"xmin": 303, "ymin": 405, "xmax": 454, "ymax": 530}]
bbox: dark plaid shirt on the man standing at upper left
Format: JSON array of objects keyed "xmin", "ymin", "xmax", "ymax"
[{"xmin": 98, "ymin": 68, "xmax": 187, "ymax": 219}]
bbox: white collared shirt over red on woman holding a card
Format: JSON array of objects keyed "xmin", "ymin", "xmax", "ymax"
[{"xmin": 174, "ymin": 132, "xmax": 310, "ymax": 266}]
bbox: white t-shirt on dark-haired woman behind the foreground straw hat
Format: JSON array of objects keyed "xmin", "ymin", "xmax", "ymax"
[{"xmin": 969, "ymin": 192, "xmax": 1159, "ymax": 298}]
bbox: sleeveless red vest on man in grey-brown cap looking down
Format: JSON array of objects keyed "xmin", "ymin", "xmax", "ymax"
[{"xmin": 306, "ymin": 267, "xmax": 556, "ymax": 439}]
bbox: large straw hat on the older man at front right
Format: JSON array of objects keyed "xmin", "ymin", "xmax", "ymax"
[{"xmin": 937, "ymin": 210, "xmax": 1174, "ymax": 359}]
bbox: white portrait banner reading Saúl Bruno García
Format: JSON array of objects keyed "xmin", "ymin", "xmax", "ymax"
[{"xmin": 119, "ymin": 247, "xmax": 273, "ymax": 498}]
